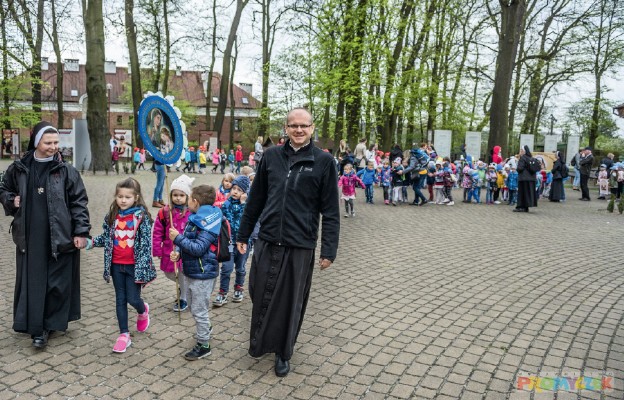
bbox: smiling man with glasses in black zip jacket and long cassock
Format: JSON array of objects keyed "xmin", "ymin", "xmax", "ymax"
[{"xmin": 236, "ymin": 108, "xmax": 340, "ymax": 377}]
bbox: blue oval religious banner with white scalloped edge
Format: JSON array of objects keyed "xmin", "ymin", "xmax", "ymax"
[{"xmin": 139, "ymin": 95, "xmax": 184, "ymax": 164}]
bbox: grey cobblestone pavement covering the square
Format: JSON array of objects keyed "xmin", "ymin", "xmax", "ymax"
[{"xmin": 0, "ymin": 162, "xmax": 624, "ymax": 399}]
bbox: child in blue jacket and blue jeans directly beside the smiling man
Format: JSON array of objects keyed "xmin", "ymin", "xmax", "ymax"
[{"xmin": 213, "ymin": 175, "xmax": 249, "ymax": 307}]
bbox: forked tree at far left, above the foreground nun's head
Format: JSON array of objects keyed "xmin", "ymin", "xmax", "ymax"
[{"xmin": 3, "ymin": 0, "xmax": 45, "ymax": 116}]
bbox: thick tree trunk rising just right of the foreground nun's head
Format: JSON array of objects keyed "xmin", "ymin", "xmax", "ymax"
[{"xmin": 82, "ymin": 0, "xmax": 111, "ymax": 173}]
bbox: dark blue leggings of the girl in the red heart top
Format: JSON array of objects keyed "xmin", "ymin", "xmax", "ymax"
[{"xmin": 111, "ymin": 264, "xmax": 145, "ymax": 333}]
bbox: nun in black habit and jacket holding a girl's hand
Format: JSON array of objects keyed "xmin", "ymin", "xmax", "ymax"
[{"xmin": 0, "ymin": 122, "xmax": 91, "ymax": 348}]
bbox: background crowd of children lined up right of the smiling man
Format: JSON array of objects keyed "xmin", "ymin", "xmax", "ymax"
[{"xmin": 337, "ymin": 152, "xmax": 584, "ymax": 212}]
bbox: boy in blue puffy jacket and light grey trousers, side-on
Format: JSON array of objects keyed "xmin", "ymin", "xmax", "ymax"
[{"xmin": 169, "ymin": 185, "xmax": 223, "ymax": 361}]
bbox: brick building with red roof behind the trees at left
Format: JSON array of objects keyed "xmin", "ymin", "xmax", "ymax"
[{"xmin": 18, "ymin": 58, "xmax": 261, "ymax": 146}]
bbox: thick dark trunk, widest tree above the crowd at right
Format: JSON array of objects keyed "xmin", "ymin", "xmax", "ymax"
[{"xmin": 487, "ymin": 0, "xmax": 526, "ymax": 159}]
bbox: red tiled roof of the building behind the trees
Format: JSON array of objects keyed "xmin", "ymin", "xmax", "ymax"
[{"xmin": 35, "ymin": 63, "xmax": 261, "ymax": 109}]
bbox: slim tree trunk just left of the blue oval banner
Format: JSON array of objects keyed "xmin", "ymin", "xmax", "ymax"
[{"xmin": 124, "ymin": 0, "xmax": 143, "ymax": 150}]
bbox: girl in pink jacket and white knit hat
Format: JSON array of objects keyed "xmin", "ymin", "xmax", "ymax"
[{"xmin": 152, "ymin": 175, "xmax": 195, "ymax": 312}]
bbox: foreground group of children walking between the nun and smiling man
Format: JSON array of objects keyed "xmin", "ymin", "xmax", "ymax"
[{"xmin": 87, "ymin": 165, "xmax": 255, "ymax": 360}]
